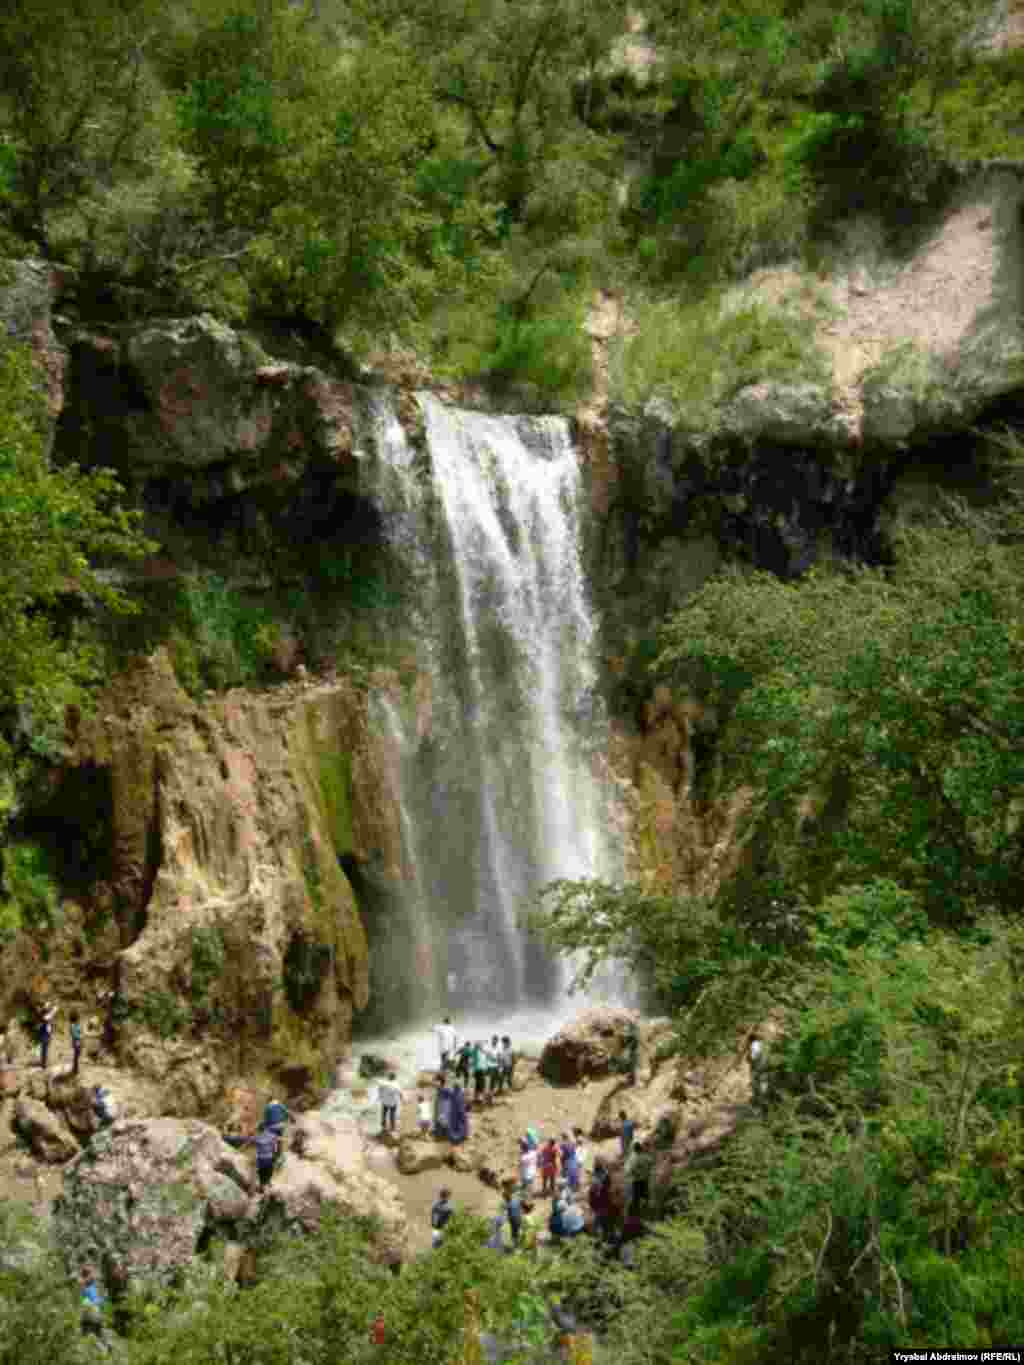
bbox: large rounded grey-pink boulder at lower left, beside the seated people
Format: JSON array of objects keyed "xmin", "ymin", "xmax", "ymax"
[{"xmin": 53, "ymin": 1118, "xmax": 254, "ymax": 1282}]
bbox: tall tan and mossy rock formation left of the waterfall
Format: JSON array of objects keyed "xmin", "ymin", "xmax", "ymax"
[{"xmin": 51, "ymin": 652, "xmax": 397, "ymax": 1115}]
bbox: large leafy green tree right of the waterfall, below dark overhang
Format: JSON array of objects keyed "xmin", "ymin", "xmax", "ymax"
[{"xmin": 661, "ymin": 507, "xmax": 1024, "ymax": 920}]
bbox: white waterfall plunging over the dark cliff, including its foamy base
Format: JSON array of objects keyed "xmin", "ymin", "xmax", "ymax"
[{"xmin": 356, "ymin": 394, "xmax": 633, "ymax": 1072}]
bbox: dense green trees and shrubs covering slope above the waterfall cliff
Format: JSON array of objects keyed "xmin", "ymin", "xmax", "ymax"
[{"xmin": 0, "ymin": 0, "xmax": 1024, "ymax": 396}]
